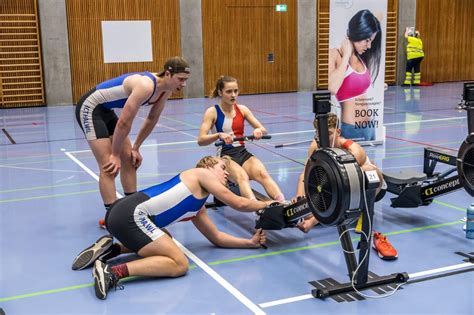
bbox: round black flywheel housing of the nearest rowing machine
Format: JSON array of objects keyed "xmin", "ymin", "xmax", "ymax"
[{"xmin": 304, "ymin": 148, "xmax": 364, "ymax": 225}]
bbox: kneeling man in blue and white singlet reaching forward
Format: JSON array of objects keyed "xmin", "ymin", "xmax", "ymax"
[{"xmin": 72, "ymin": 156, "xmax": 272, "ymax": 299}]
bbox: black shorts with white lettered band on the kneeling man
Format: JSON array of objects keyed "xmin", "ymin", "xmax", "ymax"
[{"xmin": 105, "ymin": 192, "xmax": 165, "ymax": 253}]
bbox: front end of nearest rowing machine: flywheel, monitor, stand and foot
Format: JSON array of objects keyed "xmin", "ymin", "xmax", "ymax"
[{"xmin": 304, "ymin": 92, "xmax": 408, "ymax": 299}]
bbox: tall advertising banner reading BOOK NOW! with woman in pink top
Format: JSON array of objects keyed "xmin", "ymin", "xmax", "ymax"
[{"xmin": 328, "ymin": 0, "xmax": 387, "ymax": 143}]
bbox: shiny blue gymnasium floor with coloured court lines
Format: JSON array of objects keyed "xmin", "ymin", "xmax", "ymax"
[{"xmin": 0, "ymin": 83, "xmax": 474, "ymax": 314}]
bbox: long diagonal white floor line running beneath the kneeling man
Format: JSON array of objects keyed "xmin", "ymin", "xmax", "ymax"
[{"xmin": 64, "ymin": 151, "xmax": 266, "ymax": 315}]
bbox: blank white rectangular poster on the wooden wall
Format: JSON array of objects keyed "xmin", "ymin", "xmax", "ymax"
[{"xmin": 102, "ymin": 21, "xmax": 153, "ymax": 63}]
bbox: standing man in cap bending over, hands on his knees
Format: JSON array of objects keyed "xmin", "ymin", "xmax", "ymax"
[{"xmin": 76, "ymin": 57, "xmax": 190, "ymax": 220}]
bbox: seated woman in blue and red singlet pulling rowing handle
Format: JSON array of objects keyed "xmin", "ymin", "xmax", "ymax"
[{"xmin": 198, "ymin": 76, "xmax": 285, "ymax": 202}]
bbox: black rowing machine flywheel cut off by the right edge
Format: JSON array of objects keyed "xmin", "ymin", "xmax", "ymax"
[{"xmin": 456, "ymin": 135, "xmax": 474, "ymax": 196}]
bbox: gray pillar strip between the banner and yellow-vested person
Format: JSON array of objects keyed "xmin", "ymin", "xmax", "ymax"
[{"xmin": 397, "ymin": 0, "xmax": 416, "ymax": 85}]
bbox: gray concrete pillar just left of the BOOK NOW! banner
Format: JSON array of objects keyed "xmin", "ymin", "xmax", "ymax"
[{"xmin": 298, "ymin": 0, "xmax": 316, "ymax": 91}]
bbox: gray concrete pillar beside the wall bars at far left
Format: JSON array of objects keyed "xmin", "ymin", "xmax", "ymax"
[{"xmin": 38, "ymin": 0, "xmax": 72, "ymax": 105}]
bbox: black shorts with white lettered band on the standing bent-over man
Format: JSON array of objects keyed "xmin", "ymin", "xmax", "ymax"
[{"xmin": 76, "ymin": 88, "xmax": 118, "ymax": 140}]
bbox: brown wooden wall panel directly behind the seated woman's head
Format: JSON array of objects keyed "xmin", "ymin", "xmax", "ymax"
[{"xmin": 202, "ymin": 0, "xmax": 298, "ymax": 95}]
